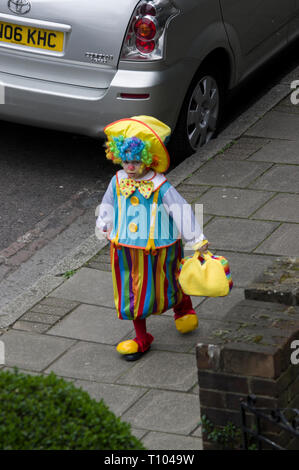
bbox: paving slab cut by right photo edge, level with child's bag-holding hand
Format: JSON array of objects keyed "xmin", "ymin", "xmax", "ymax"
[{"xmin": 255, "ymin": 224, "xmax": 299, "ymax": 256}]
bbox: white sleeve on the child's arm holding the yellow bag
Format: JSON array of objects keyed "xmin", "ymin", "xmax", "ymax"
[{"xmin": 162, "ymin": 186, "xmax": 206, "ymax": 249}]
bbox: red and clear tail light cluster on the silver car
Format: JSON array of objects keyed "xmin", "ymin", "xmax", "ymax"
[{"xmin": 121, "ymin": 0, "xmax": 179, "ymax": 60}]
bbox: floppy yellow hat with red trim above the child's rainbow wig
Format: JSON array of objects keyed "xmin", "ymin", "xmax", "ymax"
[{"xmin": 104, "ymin": 116, "xmax": 171, "ymax": 173}]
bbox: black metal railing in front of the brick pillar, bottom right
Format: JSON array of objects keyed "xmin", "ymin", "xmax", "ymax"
[{"xmin": 240, "ymin": 395, "xmax": 299, "ymax": 450}]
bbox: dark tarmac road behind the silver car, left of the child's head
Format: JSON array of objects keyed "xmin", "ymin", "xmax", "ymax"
[{"xmin": 0, "ymin": 122, "xmax": 114, "ymax": 251}]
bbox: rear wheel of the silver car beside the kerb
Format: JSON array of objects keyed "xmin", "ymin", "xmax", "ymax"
[{"xmin": 171, "ymin": 70, "xmax": 224, "ymax": 156}]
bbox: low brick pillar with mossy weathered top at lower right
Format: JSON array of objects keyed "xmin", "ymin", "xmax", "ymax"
[{"xmin": 196, "ymin": 300, "xmax": 299, "ymax": 449}]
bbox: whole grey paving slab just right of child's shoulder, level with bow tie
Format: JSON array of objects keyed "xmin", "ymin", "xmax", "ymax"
[{"xmin": 196, "ymin": 188, "xmax": 275, "ymax": 217}]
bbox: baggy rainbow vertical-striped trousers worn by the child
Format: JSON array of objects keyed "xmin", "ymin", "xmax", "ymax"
[{"xmin": 110, "ymin": 240, "xmax": 183, "ymax": 320}]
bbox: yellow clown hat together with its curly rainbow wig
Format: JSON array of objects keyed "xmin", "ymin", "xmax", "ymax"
[{"xmin": 104, "ymin": 116, "xmax": 171, "ymax": 173}]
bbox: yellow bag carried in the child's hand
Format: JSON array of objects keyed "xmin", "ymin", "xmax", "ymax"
[{"xmin": 178, "ymin": 251, "xmax": 233, "ymax": 297}]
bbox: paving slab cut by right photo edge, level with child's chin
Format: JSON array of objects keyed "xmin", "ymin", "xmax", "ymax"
[{"xmin": 250, "ymin": 164, "xmax": 299, "ymax": 193}]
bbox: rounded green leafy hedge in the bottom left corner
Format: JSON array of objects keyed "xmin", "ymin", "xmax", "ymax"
[{"xmin": 0, "ymin": 370, "xmax": 144, "ymax": 450}]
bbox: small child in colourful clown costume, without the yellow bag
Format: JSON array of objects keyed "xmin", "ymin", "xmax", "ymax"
[{"xmin": 96, "ymin": 116, "xmax": 208, "ymax": 361}]
